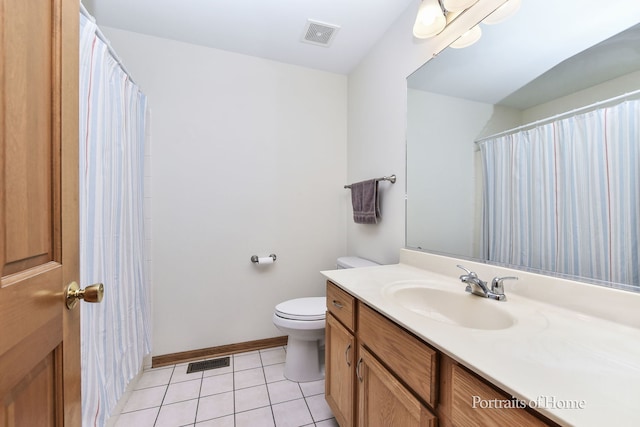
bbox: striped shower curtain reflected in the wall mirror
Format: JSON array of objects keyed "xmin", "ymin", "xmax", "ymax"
[{"xmin": 478, "ymin": 100, "xmax": 640, "ymax": 286}]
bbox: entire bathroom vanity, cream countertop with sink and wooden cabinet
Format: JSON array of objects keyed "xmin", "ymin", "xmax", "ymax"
[{"xmin": 323, "ymin": 250, "xmax": 640, "ymax": 427}]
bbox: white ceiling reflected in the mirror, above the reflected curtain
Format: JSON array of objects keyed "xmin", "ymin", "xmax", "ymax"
[{"xmin": 409, "ymin": 0, "xmax": 640, "ymax": 108}]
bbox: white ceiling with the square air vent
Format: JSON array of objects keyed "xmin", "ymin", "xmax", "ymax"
[{"xmin": 82, "ymin": 0, "xmax": 419, "ymax": 74}]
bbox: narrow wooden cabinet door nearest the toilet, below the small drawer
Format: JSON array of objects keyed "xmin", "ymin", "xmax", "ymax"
[{"xmin": 325, "ymin": 313, "xmax": 356, "ymax": 427}]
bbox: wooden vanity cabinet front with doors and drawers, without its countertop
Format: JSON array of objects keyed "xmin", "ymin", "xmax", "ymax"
[{"xmin": 325, "ymin": 281, "xmax": 557, "ymax": 427}]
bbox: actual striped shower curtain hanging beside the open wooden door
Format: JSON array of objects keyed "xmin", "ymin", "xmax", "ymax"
[{"xmin": 79, "ymin": 11, "xmax": 150, "ymax": 427}]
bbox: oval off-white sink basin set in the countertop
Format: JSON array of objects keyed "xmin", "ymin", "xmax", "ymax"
[{"xmin": 382, "ymin": 281, "xmax": 515, "ymax": 330}]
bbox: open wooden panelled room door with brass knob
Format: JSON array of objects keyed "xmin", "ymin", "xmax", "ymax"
[{"xmin": 0, "ymin": 0, "xmax": 81, "ymax": 427}]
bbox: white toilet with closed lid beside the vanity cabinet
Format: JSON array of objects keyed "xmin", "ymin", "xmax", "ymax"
[{"xmin": 273, "ymin": 257, "xmax": 378, "ymax": 382}]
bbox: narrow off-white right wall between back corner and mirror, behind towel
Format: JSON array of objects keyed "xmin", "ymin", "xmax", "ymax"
[{"xmin": 347, "ymin": 0, "xmax": 503, "ymax": 264}]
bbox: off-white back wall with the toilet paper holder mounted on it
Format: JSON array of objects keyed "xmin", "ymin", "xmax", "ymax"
[{"xmin": 103, "ymin": 28, "xmax": 348, "ymax": 355}]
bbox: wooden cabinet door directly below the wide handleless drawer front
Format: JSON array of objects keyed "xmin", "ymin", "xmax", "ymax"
[{"xmin": 356, "ymin": 346, "xmax": 437, "ymax": 427}]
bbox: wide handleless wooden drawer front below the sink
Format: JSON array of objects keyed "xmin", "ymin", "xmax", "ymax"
[{"xmin": 358, "ymin": 302, "xmax": 438, "ymax": 407}]
